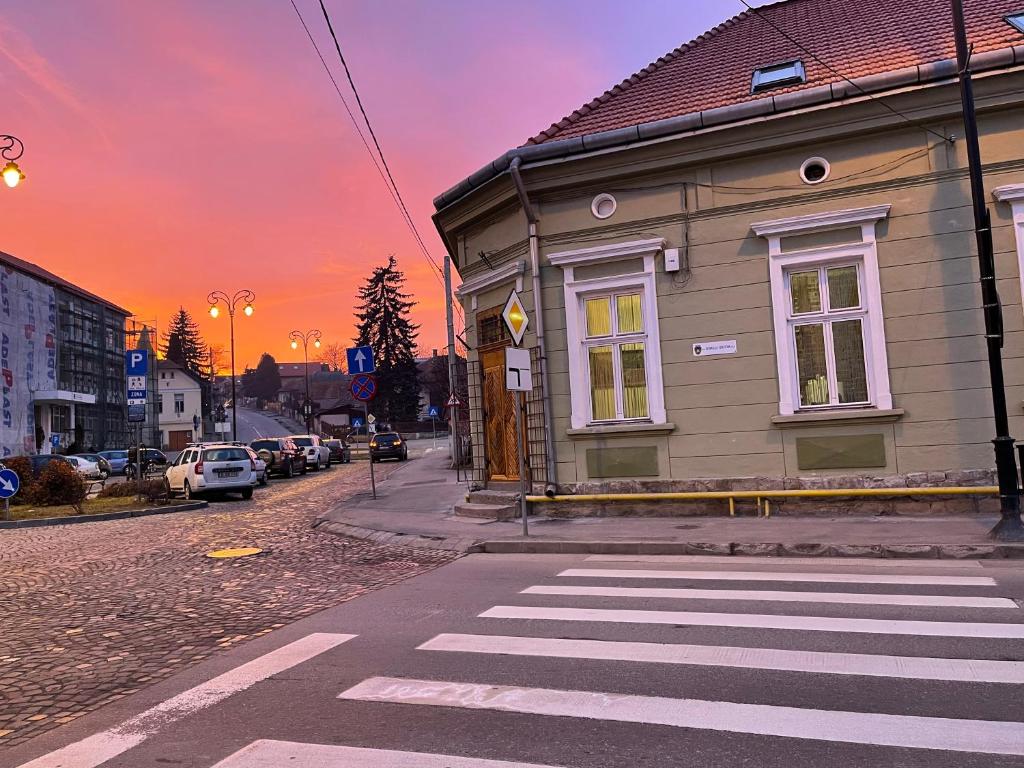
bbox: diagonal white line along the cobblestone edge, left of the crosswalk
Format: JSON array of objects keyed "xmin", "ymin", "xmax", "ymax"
[{"xmin": 20, "ymin": 632, "xmax": 355, "ymax": 768}]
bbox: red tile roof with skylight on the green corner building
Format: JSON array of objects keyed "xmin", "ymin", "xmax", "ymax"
[{"xmin": 527, "ymin": 0, "xmax": 1024, "ymax": 144}]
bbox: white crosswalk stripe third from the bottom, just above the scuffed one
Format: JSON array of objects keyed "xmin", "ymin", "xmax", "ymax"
[{"xmin": 418, "ymin": 634, "xmax": 1024, "ymax": 684}]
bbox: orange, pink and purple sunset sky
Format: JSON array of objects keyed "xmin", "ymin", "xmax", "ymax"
[{"xmin": 0, "ymin": 0, "xmax": 742, "ymax": 367}]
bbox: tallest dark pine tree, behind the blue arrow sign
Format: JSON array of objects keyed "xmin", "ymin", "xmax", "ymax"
[{"xmin": 355, "ymin": 256, "xmax": 420, "ymax": 424}]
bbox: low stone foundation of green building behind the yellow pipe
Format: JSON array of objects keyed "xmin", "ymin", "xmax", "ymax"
[{"xmin": 535, "ymin": 469, "xmax": 999, "ymax": 517}]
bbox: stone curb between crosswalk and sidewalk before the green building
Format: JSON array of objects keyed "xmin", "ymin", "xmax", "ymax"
[{"xmin": 473, "ymin": 540, "xmax": 1024, "ymax": 560}]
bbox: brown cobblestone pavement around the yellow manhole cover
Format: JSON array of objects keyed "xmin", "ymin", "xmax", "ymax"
[{"xmin": 0, "ymin": 464, "xmax": 455, "ymax": 763}]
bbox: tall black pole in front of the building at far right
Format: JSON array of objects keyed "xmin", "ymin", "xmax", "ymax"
[{"xmin": 951, "ymin": 0, "xmax": 1024, "ymax": 542}]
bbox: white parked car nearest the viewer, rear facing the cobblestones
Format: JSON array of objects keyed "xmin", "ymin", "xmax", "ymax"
[{"xmin": 164, "ymin": 442, "xmax": 258, "ymax": 499}]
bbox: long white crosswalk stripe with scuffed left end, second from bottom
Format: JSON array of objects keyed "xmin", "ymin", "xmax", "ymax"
[{"xmin": 338, "ymin": 677, "xmax": 1024, "ymax": 755}]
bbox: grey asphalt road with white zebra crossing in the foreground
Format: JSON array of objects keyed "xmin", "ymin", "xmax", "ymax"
[{"xmin": 12, "ymin": 555, "xmax": 1024, "ymax": 768}]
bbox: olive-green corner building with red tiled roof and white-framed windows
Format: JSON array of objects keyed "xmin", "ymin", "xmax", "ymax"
[{"xmin": 434, "ymin": 0, "xmax": 1024, "ymax": 518}]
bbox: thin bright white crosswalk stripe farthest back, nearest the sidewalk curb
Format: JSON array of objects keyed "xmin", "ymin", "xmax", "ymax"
[{"xmin": 558, "ymin": 568, "xmax": 995, "ymax": 587}]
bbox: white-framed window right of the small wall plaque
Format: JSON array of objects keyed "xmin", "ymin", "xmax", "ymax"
[{"xmin": 753, "ymin": 205, "xmax": 893, "ymax": 416}]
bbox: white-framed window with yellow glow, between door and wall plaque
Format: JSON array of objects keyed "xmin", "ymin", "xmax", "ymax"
[{"xmin": 548, "ymin": 238, "xmax": 666, "ymax": 429}]
